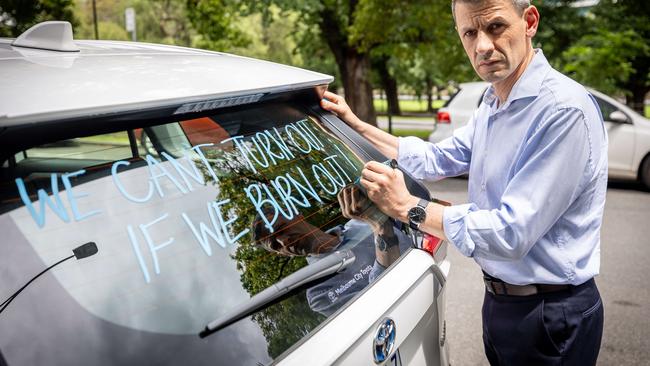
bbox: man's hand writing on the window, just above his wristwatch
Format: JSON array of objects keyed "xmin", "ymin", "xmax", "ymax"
[{"xmin": 361, "ymin": 161, "xmax": 419, "ymax": 222}]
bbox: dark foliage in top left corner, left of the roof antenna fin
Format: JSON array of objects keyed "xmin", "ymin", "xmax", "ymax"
[{"xmin": 0, "ymin": 0, "xmax": 77, "ymax": 37}]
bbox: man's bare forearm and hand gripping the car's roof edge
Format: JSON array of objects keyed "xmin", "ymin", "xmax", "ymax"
[{"xmin": 321, "ymin": 91, "xmax": 399, "ymax": 159}]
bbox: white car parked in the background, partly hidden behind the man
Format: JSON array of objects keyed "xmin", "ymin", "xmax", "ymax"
[{"xmin": 429, "ymin": 82, "xmax": 650, "ymax": 189}]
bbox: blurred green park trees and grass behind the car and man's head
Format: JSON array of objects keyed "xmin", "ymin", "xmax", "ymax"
[{"xmin": 0, "ymin": 0, "xmax": 650, "ymax": 138}]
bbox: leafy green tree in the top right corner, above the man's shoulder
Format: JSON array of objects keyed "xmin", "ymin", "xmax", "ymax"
[{"xmin": 563, "ymin": 0, "xmax": 650, "ymax": 113}]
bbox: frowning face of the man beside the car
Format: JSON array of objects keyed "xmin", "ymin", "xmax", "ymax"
[{"xmin": 455, "ymin": 0, "xmax": 530, "ymax": 83}]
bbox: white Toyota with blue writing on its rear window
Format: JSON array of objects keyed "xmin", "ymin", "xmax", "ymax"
[{"xmin": 0, "ymin": 22, "xmax": 450, "ymax": 366}]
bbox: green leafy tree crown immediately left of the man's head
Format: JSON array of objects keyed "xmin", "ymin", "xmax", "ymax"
[{"xmin": 351, "ymin": 0, "xmax": 475, "ymax": 113}]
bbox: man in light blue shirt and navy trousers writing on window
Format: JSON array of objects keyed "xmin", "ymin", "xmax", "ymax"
[{"xmin": 322, "ymin": 0, "xmax": 607, "ymax": 365}]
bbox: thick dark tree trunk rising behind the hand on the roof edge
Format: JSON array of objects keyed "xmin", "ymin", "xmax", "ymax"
[{"xmin": 319, "ymin": 5, "xmax": 377, "ymax": 126}]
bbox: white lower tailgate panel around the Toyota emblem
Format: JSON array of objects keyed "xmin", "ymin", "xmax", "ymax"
[{"xmin": 278, "ymin": 250, "xmax": 444, "ymax": 365}]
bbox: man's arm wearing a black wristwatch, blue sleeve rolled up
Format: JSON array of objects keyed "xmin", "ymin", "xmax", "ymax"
[{"xmin": 361, "ymin": 108, "xmax": 602, "ymax": 260}]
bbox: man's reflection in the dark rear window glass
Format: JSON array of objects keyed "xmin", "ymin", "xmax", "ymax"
[{"xmin": 251, "ymin": 185, "xmax": 410, "ymax": 316}]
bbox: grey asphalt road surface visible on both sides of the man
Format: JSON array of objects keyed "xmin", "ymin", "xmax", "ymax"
[{"xmin": 420, "ymin": 179, "xmax": 650, "ymax": 365}]
